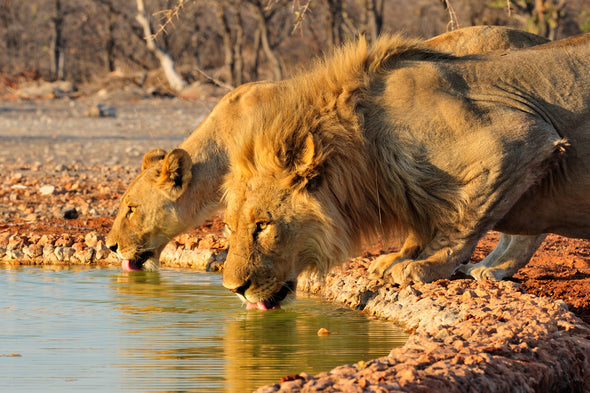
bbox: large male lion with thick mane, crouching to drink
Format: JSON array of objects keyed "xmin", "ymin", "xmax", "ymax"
[{"xmin": 223, "ymin": 34, "xmax": 590, "ymax": 309}]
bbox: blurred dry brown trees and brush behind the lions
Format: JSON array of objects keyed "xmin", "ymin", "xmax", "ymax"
[{"xmin": 0, "ymin": 0, "xmax": 590, "ymax": 91}]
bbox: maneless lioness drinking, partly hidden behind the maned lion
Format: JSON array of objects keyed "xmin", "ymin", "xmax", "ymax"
[{"xmin": 107, "ymin": 26, "xmax": 547, "ymax": 270}]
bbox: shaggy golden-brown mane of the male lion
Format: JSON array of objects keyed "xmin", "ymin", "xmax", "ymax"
[{"xmin": 225, "ymin": 35, "xmax": 466, "ymax": 271}]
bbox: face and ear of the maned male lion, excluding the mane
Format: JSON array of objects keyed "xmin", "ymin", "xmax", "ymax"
[{"xmin": 223, "ymin": 132, "xmax": 347, "ymax": 310}]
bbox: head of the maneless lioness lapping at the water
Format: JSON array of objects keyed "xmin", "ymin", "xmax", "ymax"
[{"xmin": 107, "ymin": 149, "xmax": 192, "ymax": 270}]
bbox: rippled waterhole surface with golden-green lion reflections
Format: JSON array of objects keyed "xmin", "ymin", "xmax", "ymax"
[{"xmin": 0, "ymin": 267, "xmax": 407, "ymax": 393}]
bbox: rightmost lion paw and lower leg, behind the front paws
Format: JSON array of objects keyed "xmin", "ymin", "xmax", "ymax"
[{"xmin": 466, "ymin": 234, "xmax": 546, "ymax": 280}]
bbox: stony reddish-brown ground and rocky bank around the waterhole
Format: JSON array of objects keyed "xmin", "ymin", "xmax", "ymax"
[{"xmin": 0, "ymin": 95, "xmax": 590, "ymax": 392}]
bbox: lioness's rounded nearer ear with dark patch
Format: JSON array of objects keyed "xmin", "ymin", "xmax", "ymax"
[{"xmin": 158, "ymin": 149, "xmax": 193, "ymax": 201}]
